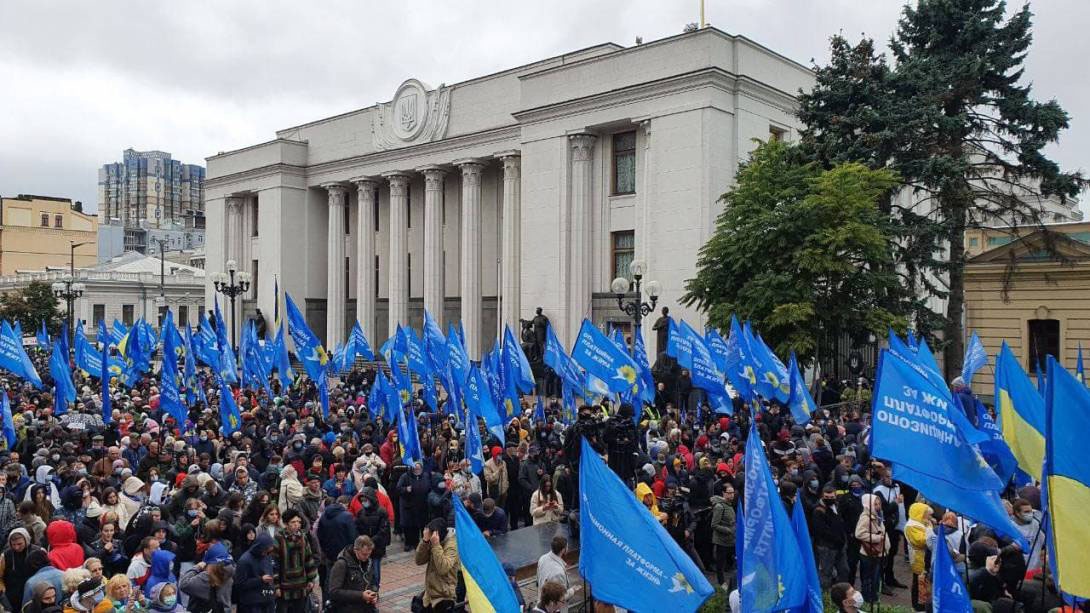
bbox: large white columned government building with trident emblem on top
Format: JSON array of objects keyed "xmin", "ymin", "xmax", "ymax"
[{"xmin": 204, "ymin": 27, "xmax": 813, "ymax": 359}]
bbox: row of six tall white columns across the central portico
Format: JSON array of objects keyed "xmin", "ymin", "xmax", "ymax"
[{"xmin": 318, "ymin": 152, "xmax": 521, "ymax": 359}]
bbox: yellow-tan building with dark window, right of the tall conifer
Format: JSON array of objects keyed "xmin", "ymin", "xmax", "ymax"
[{"xmin": 965, "ymin": 221, "xmax": 1090, "ymax": 396}]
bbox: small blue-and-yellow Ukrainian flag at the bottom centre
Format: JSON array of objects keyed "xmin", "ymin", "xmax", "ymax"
[{"xmin": 453, "ymin": 496, "xmax": 519, "ymax": 613}]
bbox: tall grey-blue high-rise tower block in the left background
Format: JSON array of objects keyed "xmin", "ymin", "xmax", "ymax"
[{"xmin": 98, "ymin": 148, "xmax": 205, "ymax": 262}]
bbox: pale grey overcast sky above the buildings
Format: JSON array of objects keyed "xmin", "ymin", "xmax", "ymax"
[{"xmin": 0, "ymin": 0, "xmax": 1090, "ymax": 209}]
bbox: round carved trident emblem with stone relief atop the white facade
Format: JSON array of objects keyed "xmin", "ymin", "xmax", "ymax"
[{"xmin": 371, "ymin": 79, "xmax": 450, "ymax": 151}]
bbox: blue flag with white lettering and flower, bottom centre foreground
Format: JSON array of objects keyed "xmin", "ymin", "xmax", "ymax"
[{"xmin": 578, "ymin": 438, "xmax": 715, "ymax": 612}]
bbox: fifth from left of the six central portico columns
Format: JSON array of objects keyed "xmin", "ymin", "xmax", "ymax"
[{"xmin": 455, "ymin": 159, "xmax": 484, "ymax": 360}]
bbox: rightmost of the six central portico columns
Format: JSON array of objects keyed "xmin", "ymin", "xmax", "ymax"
[{"xmin": 499, "ymin": 152, "xmax": 522, "ymax": 335}]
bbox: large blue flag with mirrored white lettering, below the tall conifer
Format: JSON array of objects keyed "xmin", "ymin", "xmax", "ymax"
[{"xmin": 871, "ymin": 344, "xmax": 1029, "ymax": 549}]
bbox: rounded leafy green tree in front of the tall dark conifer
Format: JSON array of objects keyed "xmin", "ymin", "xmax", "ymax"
[{"xmin": 682, "ymin": 142, "xmax": 904, "ymax": 363}]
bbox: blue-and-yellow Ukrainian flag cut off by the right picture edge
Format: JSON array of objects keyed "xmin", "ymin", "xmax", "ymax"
[{"xmin": 1044, "ymin": 356, "xmax": 1090, "ymax": 598}]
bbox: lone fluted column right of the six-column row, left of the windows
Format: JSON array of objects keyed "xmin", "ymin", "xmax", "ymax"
[{"xmin": 567, "ymin": 134, "xmax": 597, "ymax": 345}]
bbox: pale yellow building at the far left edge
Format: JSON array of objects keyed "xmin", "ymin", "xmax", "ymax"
[{"xmin": 0, "ymin": 194, "xmax": 98, "ymax": 275}]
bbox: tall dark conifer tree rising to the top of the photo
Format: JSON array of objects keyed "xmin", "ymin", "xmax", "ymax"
[{"xmin": 800, "ymin": 0, "xmax": 1086, "ymax": 376}]
